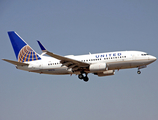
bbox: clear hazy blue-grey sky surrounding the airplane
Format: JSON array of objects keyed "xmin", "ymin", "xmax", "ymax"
[{"xmin": 0, "ymin": 0, "xmax": 158, "ymax": 120}]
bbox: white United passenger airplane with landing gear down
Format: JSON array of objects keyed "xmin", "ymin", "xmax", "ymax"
[{"xmin": 2, "ymin": 31, "xmax": 157, "ymax": 82}]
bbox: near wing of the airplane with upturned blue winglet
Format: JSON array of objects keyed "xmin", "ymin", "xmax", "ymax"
[{"xmin": 37, "ymin": 41, "xmax": 90, "ymax": 70}]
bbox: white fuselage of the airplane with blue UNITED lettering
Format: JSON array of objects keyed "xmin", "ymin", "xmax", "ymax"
[{"xmin": 17, "ymin": 51, "xmax": 156, "ymax": 75}]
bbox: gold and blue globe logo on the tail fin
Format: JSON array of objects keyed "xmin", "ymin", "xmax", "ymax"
[{"xmin": 18, "ymin": 45, "xmax": 41, "ymax": 62}]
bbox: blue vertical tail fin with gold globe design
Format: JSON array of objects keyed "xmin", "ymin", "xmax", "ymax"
[{"xmin": 8, "ymin": 31, "xmax": 41, "ymax": 62}]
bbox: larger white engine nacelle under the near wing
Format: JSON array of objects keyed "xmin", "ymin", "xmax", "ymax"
[{"xmin": 89, "ymin": 63, "xmax": 106, "ymax": 72}]
